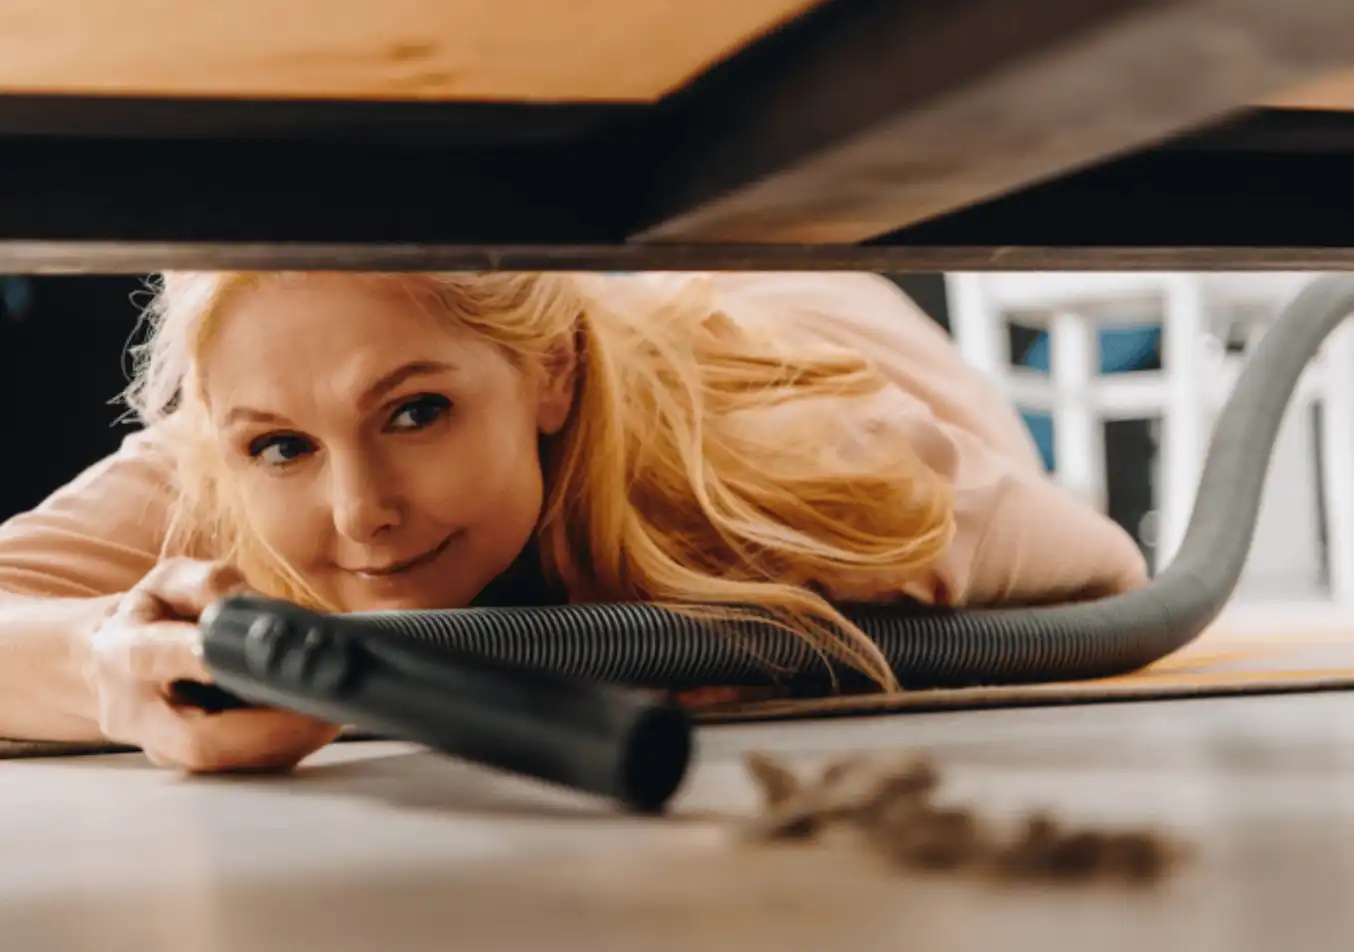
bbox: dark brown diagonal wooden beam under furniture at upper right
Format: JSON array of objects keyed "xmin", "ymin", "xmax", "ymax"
[{"xmin": 632, "ymin": 0, "xmax": 1354, "ymax": 244}]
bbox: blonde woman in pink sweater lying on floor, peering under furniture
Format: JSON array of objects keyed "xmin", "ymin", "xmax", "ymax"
[{"xmin": 0, "ymin": 274, "xmax": 1144, "ymax": 771}]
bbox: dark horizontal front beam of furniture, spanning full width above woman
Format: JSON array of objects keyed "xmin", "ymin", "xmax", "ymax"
[{"xmin": 0, "ymin": 117, "xmax": 1354, "ymax": 274}]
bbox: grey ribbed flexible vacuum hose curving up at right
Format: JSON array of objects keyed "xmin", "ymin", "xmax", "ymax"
[{"xmin": 356, "ymin": 275, "xmax": 1354, "ymax": 688}]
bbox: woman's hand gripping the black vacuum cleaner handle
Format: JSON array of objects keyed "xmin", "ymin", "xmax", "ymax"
[{"xmin": 89, "ymin": 559, "xmax": 340, "ymax": 773}]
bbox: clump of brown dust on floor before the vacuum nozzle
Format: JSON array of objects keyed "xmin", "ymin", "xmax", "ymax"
[{"xmin": 741, "ymin": 752, "xmax": 1182, "ymax": 883}]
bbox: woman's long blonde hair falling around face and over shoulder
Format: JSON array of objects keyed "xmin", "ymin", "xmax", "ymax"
[{"xmin": 126, "ymin": 272, "xmax": 953, "ymax": 688}]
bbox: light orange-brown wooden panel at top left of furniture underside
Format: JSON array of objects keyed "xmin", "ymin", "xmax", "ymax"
[{"xmin": 0, "ymin": 0, "xmax": 815, "ymax": 102}]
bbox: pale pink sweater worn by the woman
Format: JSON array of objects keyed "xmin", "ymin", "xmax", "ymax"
[{"xmin": 0, "ymin": 274, "xmax": 1145, "ymax": 604}]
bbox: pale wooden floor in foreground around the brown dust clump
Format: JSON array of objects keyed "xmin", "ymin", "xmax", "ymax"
[{"xmin": 0, "ymin": 693, "xmax": 1354, "ymax": 952}]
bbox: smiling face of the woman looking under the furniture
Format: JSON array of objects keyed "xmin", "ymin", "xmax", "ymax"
[{"xmin": 202, "ymin": 276, "xmax": 573, "ymax": 611}]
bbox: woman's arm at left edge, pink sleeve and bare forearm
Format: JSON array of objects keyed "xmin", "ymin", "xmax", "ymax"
[{"xmin": 0, "ymin": 431, "xmax": 171, "ymax": 741}]
